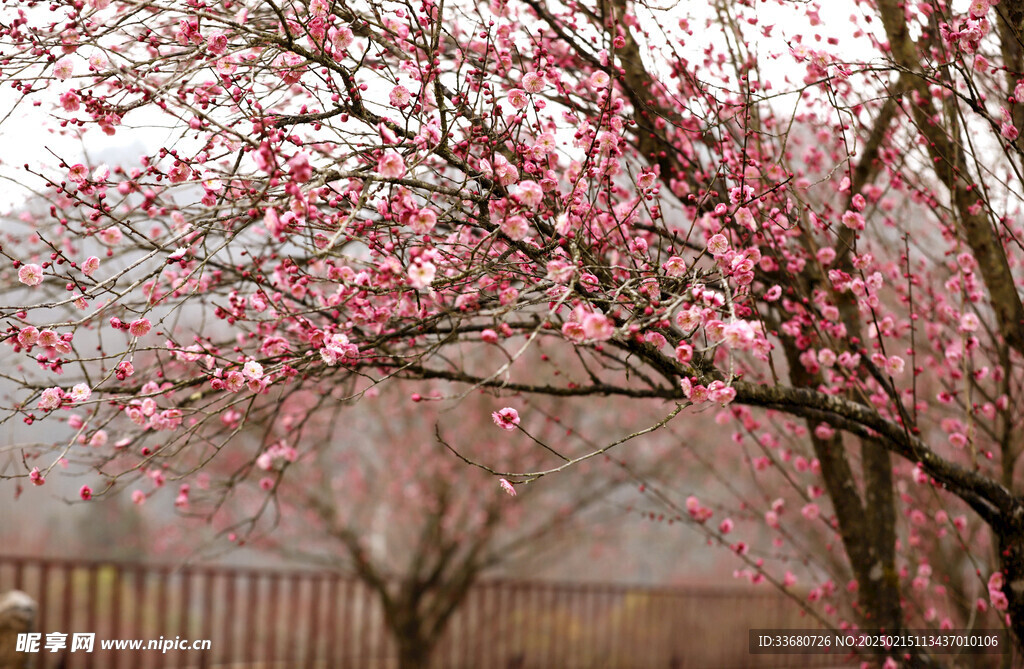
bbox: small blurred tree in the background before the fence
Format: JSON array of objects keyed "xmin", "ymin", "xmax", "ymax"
[{"xmin": 197, "ymin": 384, "xmax": 636, "ymax": 669}]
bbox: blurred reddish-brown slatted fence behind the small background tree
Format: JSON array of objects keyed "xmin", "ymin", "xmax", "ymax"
[{"xmin": 0, "ymin": 556, "xmax": 841, "ymax": 669}]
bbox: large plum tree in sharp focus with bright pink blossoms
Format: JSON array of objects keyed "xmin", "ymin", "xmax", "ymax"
[{"xmin": 0, "ymin": 0, "xmax": 1024, "ymax": 665}]
